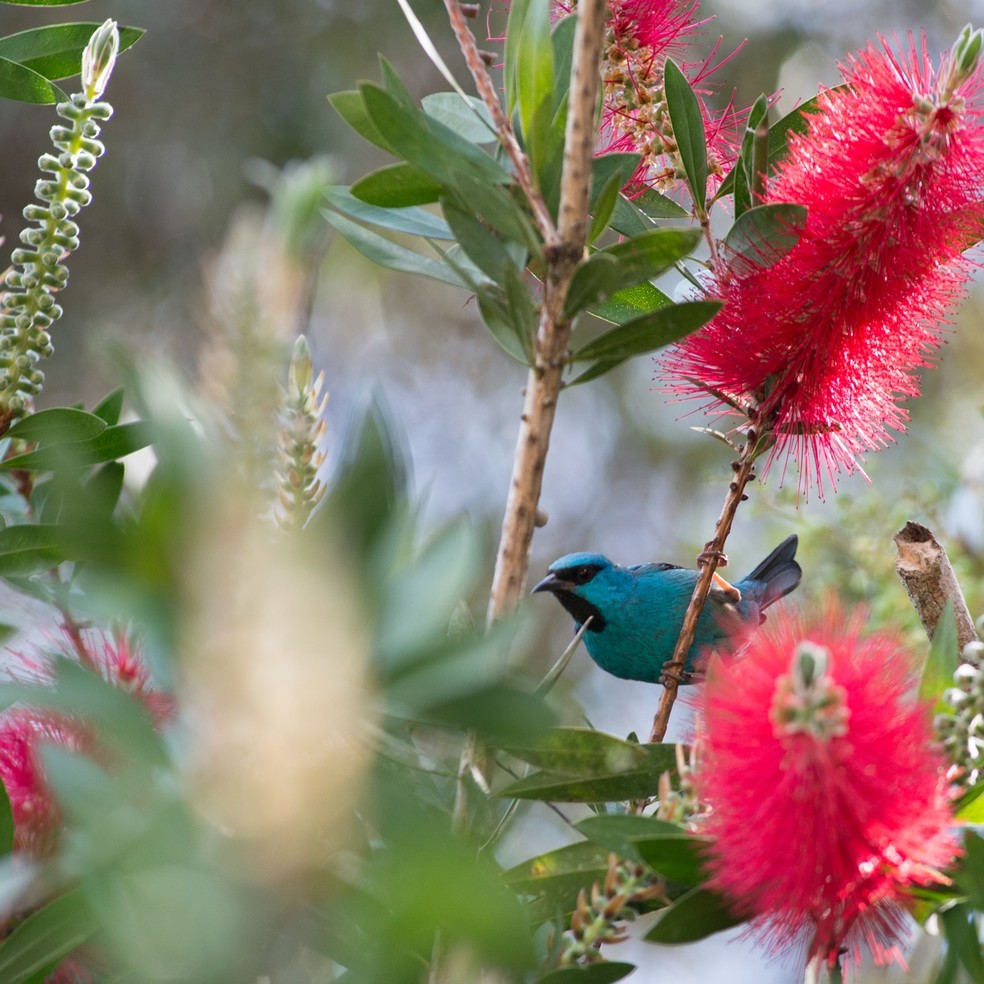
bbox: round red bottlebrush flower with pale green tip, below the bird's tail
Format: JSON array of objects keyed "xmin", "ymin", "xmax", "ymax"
[{"xmin": 696, "ymin": 606, "xmax": 959, "ymax": 964}]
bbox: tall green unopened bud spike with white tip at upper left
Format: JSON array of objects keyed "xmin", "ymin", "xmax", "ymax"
[{"xmin": 0, "ymin": 20, "xmax": 119, "ymax": 433}]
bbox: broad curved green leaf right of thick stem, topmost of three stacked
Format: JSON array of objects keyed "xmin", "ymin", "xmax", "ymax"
[{"xmin": 564, "ymin": 229, "xmax": 700, "ymax": 318}]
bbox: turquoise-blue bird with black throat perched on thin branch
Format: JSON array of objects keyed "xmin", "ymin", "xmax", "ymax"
[{"xmin": 533, "ymin": 535, "xmax": 802, "ymax": 683}]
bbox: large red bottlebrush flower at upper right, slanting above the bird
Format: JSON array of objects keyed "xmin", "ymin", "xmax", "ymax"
[{"xmin": 661, "ymin": 32, "xmax": 984, "ymax": 496}]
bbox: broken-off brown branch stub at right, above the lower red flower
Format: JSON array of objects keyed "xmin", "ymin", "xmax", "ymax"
[{"xmin": 893, "ymin": 522, "xmax": 977, "ymax": 651}]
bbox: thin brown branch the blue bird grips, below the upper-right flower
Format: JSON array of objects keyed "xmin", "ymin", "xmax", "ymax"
[{"xmin": 649, "ymin": 430, "xmax": 761, "ymax": 742}]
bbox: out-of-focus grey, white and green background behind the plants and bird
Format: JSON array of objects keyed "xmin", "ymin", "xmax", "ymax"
[{"xmin": 0, "ymin": 0, "xmax": 984, "ymax": 981}]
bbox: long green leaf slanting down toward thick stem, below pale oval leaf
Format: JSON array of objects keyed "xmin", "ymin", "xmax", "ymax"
[{"xmin": 359, "ymin": 82, "xmax": 511, "ymax": 187}]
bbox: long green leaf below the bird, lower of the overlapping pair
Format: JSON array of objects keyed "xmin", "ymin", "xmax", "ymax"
[{"xmin": 498, "ymin": 735, "xmax": 676, "ymax": 803}]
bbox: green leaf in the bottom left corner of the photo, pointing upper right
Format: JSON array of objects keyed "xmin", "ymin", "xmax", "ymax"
[{"xmin": 0, "ymin": 891, "xmax": 98, "ymax": 984}]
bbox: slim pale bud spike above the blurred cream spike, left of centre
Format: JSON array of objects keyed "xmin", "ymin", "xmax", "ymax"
[{"xmin": 277, "ymin": 335, "xmax": 328, "ymax": 529}]
